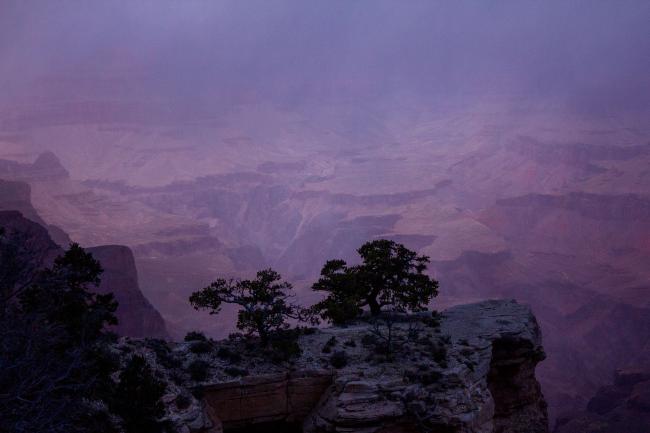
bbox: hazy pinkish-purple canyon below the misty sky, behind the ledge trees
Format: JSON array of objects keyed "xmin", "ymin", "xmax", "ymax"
[{"xmin": 0, "ymin": 97, "xmax": 650, "ymax": 419}]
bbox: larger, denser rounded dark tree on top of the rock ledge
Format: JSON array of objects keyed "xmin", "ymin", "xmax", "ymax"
[{"xmin": 312, "ymin": 239, "xmax": 438, "ymax": 323}]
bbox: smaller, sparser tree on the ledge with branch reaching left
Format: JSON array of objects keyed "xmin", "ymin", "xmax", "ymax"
[{"xmin": 190, "ymin": 269, "xmax": 306, "ymax": 346}]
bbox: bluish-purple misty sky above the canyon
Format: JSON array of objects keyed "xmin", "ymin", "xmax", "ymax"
[{"xmin": 0, "ymin": 0, "xmax": 650, "ymax": 109}]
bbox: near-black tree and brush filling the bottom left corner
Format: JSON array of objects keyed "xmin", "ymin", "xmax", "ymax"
[{"xmin": 0, "ymin": 241, "xmax": 117, "ymax": 433}]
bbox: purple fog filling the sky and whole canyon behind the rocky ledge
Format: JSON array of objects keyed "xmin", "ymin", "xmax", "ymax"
[{"xmin": 0, "ymin": 0, "xmax": 650, "ymax": 426}]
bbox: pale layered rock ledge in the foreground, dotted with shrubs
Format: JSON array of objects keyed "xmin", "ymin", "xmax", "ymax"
[{"xmin": 117, "ymin": 301, "xmax": 548, "ymax": 433}]
